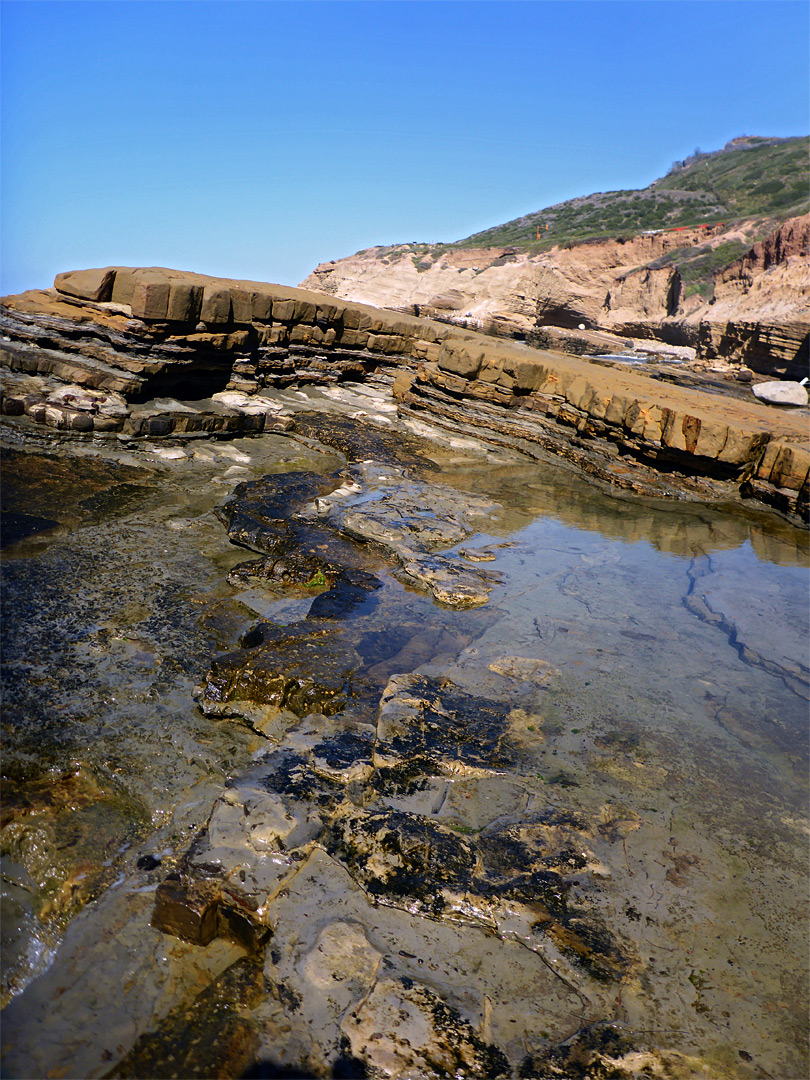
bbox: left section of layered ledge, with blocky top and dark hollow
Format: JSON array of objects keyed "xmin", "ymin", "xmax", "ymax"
[{"xmin": 0, "ymin": 268, "xmax": 442, "ymax": 435}]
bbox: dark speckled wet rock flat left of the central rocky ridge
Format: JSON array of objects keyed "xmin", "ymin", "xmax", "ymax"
[{"xmin": 2, "ymin": 425, "xmax": 343, "ymax": 1001}]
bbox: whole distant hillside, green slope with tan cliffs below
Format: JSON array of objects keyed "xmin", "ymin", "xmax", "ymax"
[{"xmin": 301, "ymin": 136, "xmax": 810, "ymax": 378}]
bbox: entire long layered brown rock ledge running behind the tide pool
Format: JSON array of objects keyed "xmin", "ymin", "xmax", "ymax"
[{"xmin": 0, "ymin": 261, "xmax": 810, "ymax": 519}]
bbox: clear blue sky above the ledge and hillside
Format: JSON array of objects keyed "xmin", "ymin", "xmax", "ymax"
[{"xmin": 0, "ymin": 0, "xmax": 810, "ymax": 294}]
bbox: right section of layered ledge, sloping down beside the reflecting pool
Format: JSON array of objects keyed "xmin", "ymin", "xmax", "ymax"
[{"xmin": 394, "ymin": 342, "xmax": 810, "ymax": 518}]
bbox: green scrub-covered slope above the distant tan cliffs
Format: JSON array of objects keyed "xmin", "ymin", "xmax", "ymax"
[{"xmin": 447, "ymin": 136, "xmax": 810, "ymax": 252}]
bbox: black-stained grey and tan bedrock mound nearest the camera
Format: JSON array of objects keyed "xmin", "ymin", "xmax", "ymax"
[{"xmin": 152, "ymin": 674, "xmax": 639, "ymax": 1080}]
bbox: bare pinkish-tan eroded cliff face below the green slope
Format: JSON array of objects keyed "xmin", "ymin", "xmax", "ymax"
[{"xmin": 301, "ymin": 216, "xmax": 810, "ymax": 378}]
